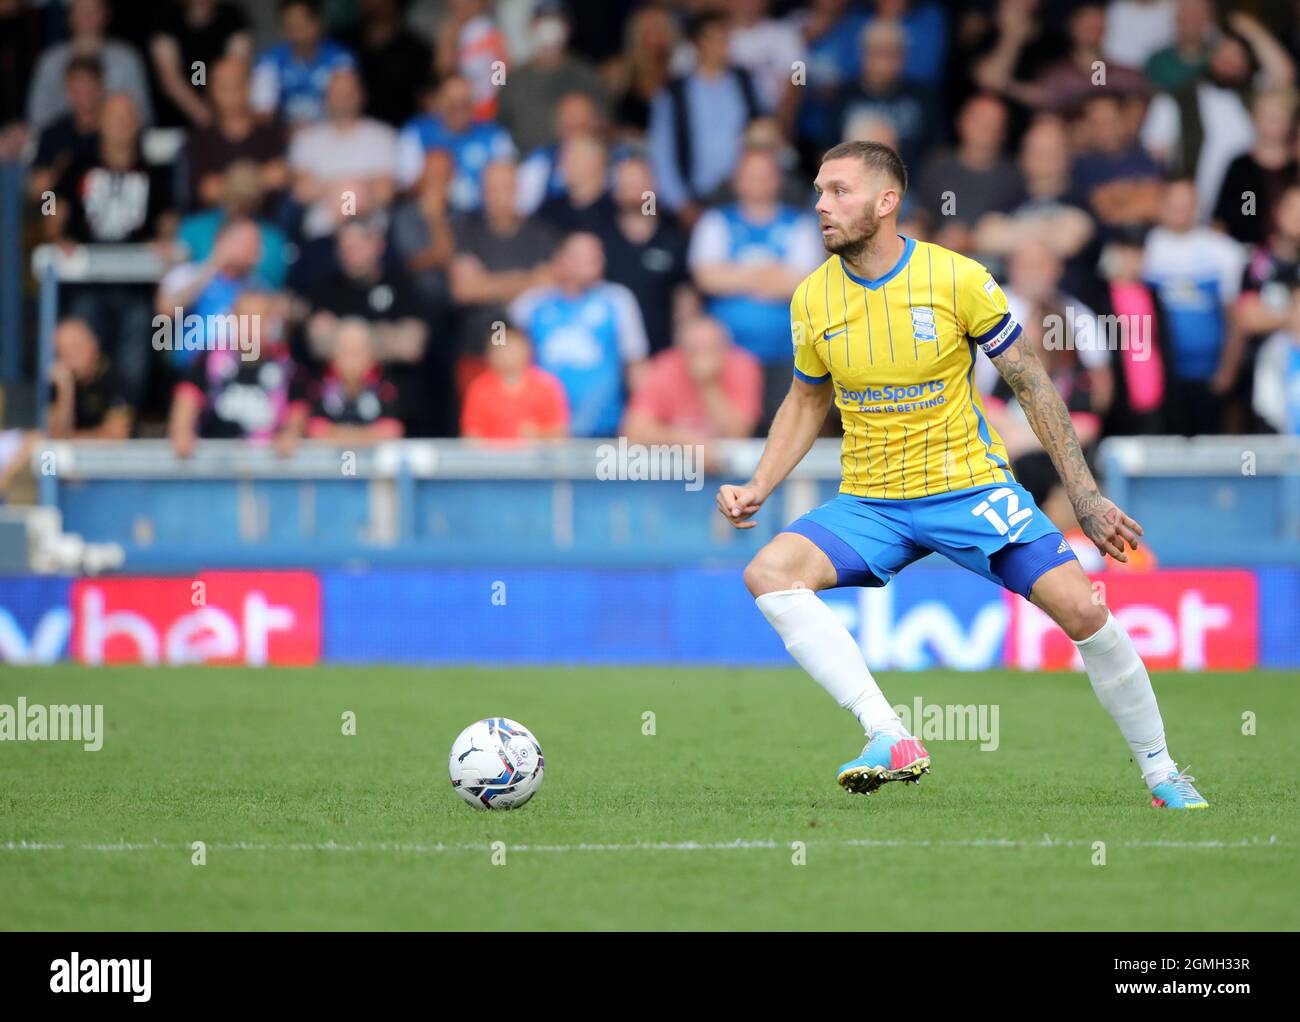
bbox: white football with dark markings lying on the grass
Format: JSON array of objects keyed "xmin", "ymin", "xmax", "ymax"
[{"xmin": 447, "ymin": 716, "xmax": 543, "ymax": 809}]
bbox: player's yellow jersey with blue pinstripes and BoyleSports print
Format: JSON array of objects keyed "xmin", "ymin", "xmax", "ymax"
[{"xmin": 790, "ymin": 235, "xmax": 1021, "ymax": 499}]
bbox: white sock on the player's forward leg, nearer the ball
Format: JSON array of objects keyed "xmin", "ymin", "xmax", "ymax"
[{"xmin": 754, "ymin": 589, "xmax": 907, "ymax": 735}]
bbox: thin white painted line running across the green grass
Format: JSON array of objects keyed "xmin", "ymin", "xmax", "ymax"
[{"xmin": 0, "ymin": 833, "xmax": 1283, "ymax": 856}]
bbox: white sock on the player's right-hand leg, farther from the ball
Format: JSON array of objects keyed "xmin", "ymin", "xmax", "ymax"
[{"xmin": 1075, "ymin": 611, "xmax": 1178, "ymax": 788}]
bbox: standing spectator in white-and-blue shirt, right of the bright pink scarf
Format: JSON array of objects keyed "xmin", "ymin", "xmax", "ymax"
[{"xmin": 1143, "ymin": 178, "xmax": 1245, "ymax": 436}]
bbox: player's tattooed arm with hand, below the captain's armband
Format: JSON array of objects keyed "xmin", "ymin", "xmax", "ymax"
[{"xmin": 993, "ymin": 339, "xmax": 1143, "ymax": 560}]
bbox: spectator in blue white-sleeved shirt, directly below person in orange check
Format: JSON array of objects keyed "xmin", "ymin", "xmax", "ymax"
[{"xmin": 398, "ymin": 74, "xmax": 515, "ymax": 213}]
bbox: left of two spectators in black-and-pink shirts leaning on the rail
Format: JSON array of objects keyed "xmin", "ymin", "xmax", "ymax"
[{"xmin": 168, "ymin": 291, "xmax": 307, "ymax": 458}]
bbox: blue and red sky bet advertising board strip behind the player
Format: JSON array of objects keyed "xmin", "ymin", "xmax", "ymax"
[{"xmin": 0, "ymin": 566, "xmax": 1284, "ymax": 670}]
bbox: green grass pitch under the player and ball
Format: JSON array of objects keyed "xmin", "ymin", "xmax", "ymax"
[{"xmin": 0, "ymin": 666, "xmax": 1300, "ymax": 930}]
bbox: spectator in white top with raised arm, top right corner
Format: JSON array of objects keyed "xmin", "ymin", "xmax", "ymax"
[{"xmin": 1141, "ymin": 12, "xmax": 1295, "ymax": 220}]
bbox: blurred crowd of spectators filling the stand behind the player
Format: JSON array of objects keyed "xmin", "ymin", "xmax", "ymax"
[{"xmin": 0, "ymin": 0, "xmax": 1300, "ymax": 481}]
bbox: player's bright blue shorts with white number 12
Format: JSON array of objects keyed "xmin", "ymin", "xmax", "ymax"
[{"xmin": 785, "ymin": 482, "xmax": 1075, "ymax": 598}]
